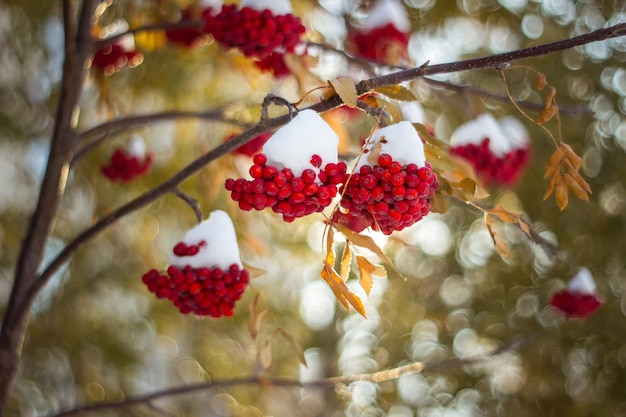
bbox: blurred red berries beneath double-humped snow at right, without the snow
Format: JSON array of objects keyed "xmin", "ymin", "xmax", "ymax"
[{"xmin": 450, "ymin": 138, "xmax": 530, "ymax": 186}]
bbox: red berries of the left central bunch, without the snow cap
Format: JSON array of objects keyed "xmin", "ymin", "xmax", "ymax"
[{"xmin": 225, "ymin": 153, "xmax": 348, "ymax": 223}]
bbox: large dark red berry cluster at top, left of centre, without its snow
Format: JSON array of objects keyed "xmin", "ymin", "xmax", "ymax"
[{"xmin": 205, "ymin": 4, "xmax": 306, "ymax": 59}]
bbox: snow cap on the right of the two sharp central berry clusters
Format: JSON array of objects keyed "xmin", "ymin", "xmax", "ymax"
[{"xmin": 355, "ymin": 120, "xmax": 426, "ymax": 171}]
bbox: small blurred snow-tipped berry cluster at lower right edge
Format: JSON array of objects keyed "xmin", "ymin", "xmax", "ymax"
[{"xmin": 550, "ymin": 268, "xmax": 602, "ymax": 318}]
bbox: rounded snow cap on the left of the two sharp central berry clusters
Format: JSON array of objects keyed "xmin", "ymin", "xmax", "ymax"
[{"xmin": 263, "ymin": 110, "xmax": 339, "ymax": 176}]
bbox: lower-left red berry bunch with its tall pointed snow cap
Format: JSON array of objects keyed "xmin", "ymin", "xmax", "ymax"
[{"xmin": 142, "ymin": 210, "xmax": 250, "ymax": 317}]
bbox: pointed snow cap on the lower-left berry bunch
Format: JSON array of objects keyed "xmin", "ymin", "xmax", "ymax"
[{"xmin": 170, "ymin": 210, "xmax": 243, "ymax": 270}]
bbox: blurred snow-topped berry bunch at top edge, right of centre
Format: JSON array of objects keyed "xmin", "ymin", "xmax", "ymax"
[{"xmin": 348, "ymin": 0, "xmax": 411, "ymax": 63}]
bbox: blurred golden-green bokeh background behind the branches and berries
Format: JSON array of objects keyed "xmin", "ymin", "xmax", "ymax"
[{"xmin": 0, "ymin": 0, "xmax": 626, "ymax": 417}]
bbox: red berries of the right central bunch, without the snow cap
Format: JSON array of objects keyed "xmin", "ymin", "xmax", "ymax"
[{"xmin": 339, "ymin": 153, "xmax": 439, "ymax": 235}]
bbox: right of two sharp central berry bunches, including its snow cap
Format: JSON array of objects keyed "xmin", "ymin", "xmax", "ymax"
[{"xmin": 334, "ymin": 121, "xmax": 439, "ymax": 235}]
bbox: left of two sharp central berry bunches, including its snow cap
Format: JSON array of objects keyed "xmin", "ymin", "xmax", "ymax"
[{"xmin": 226, "ymin": 110, "xmax": 347, "ymax": 222}]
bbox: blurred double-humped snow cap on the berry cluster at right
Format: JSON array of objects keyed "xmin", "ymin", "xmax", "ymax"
[{"xmin": 450, "ymin": 113, "xmax": 528, "ymax": 157}]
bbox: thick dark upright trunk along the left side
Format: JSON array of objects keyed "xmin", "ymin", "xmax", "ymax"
[{"xmin": 0, "ymin": 0, "xmax": 96, "ymax": 416}]
